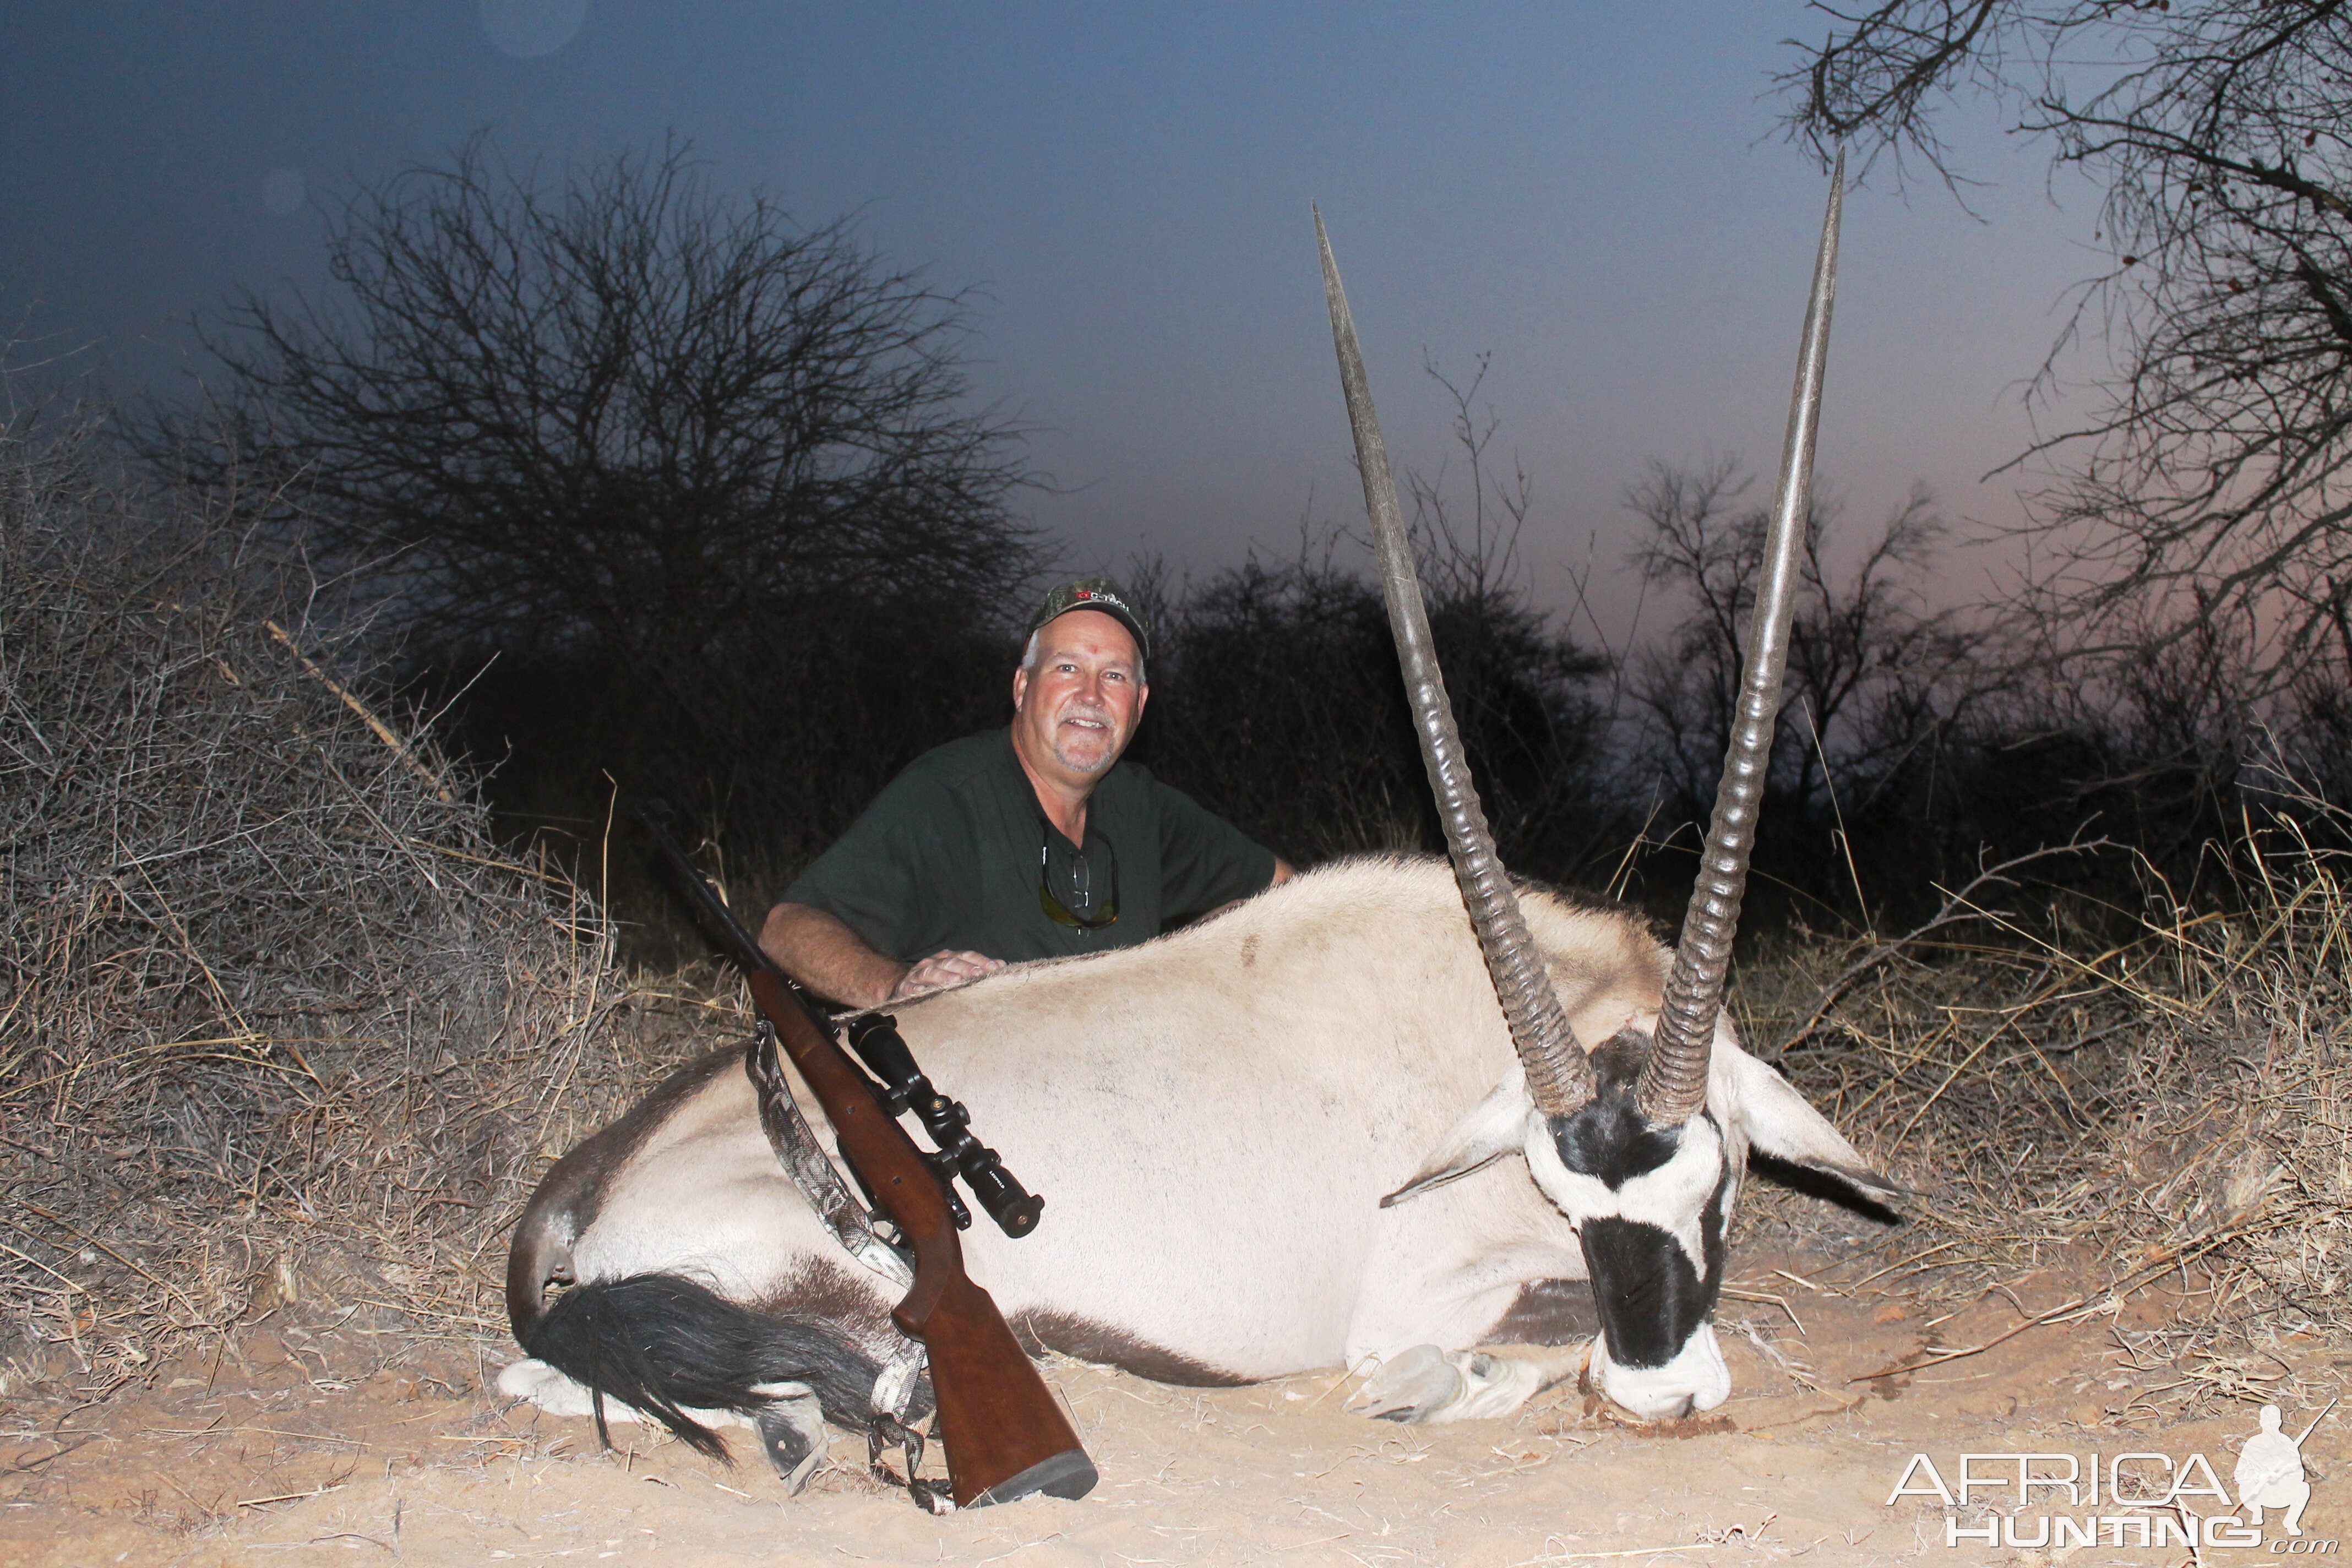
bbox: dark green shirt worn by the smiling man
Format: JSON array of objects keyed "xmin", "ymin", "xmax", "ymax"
[{"xmin": 783, "ymin": 729, "xmax": 1275, "ymax": 964}]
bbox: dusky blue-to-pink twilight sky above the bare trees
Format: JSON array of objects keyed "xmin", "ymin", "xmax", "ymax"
[{"xmin": 0, "ymin": 0, "xmax": 2098, "ymax": 639}]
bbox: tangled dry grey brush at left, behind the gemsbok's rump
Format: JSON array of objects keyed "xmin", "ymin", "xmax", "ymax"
[{"xmin": 0, "ymin": 430, "xmax": 638, "ymax": 1396}]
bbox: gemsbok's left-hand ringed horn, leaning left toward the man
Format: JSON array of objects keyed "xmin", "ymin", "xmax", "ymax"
[{"xmin": 1315, "ymin": 207, "xmax": 1592, "ymax": 1117}]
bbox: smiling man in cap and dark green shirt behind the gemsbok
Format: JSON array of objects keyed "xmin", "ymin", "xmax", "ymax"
[{"xmin": 760, "ymin": 578, "xmax": 1291, "ymax": 1006}]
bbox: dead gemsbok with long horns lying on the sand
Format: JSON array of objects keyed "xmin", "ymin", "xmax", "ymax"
[{"xmin": 501, "ymin": 166, "xmax": 1893, "ymax": 1472}]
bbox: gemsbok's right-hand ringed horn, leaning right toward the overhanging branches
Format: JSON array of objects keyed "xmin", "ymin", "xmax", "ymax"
[{"xmin": 1635, "ymin": 153, "xmax": 1847, "ymax": 1126}]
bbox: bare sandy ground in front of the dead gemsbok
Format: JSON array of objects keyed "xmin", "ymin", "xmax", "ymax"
[{"xmin": 0, "ymin": 1253, "xmax": 2352, "ymax": 1568}]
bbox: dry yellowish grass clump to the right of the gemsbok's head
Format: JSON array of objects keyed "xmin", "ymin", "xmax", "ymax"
[{"xmin": 1743, "ymin": 799, "xmax": 2352, "ymax": 1401}]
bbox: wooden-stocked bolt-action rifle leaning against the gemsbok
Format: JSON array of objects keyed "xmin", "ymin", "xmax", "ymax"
[{"xmin": 638, "ymin": 811, "xmax": 1096, "ymax": 1507}]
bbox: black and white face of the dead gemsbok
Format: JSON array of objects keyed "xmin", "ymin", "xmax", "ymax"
[{"xmin": 1527, "ymin": 1035, "xmax": 1733, "ymax": 1420}]
